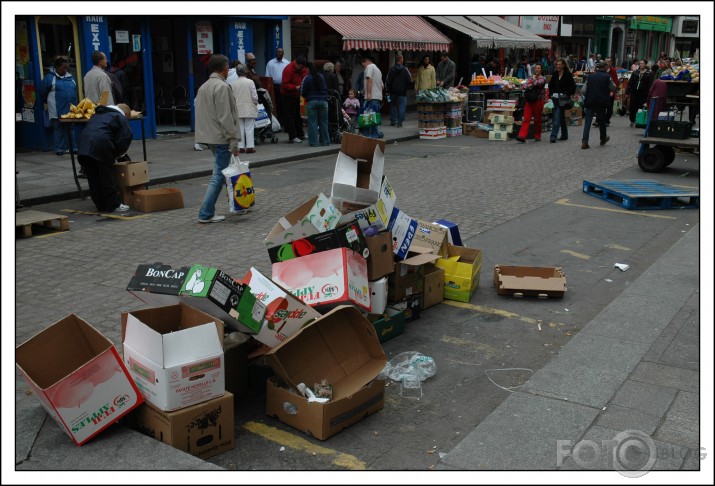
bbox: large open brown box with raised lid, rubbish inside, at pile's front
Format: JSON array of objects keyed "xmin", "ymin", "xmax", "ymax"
[{"xmin": 266, "ymin": 306, "xmax": 387, "ymax": 440}]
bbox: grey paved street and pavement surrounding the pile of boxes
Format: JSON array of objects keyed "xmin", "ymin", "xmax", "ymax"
[{"xmin": 3, "ymin": 114, "xmax": 712, "ymax": 482}]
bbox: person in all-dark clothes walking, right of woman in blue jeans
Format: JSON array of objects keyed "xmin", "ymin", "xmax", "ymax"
[{"xmin": 581, "ymin": 61, "xmax": 616, "ymax": 149}]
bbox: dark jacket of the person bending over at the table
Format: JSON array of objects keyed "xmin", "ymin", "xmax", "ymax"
[{"xmin": 78, "ymin": 106, "xmax": 132, "ymax": 165}]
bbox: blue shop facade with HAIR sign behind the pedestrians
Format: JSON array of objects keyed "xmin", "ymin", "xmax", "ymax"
[{"xmin": 15, "ymin": 15, "xmax": 290, "ymax": 151}]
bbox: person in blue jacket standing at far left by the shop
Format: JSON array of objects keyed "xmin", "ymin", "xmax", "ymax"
[{"xmin": 37, "ymin": 57, "xmax": 77, "ymax": 155}]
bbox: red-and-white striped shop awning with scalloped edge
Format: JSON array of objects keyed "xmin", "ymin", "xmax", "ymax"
[{"xmin": 320, "ymin": 15, "xmax": 452, "ymax": 51}]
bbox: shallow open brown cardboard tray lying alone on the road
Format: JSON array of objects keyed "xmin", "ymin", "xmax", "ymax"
[{"xmin": 494, "ymin": 265, "xmax": 566, "ymax": 297}]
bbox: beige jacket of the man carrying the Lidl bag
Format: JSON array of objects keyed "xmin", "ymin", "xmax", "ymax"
[{"xmin": 194, "ymin": 73, "xmax": 241, "ymax": 152}]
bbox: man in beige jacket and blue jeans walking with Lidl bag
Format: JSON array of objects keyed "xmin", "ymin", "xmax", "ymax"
[{"xmin": 195, "ymin": 54, "xmax": 241, "ymax": 223}]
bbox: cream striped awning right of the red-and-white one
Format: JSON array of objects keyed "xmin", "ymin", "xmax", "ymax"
[{"xmin": 429, "ymin": 15, "xmax": 551, "ymax": 49}]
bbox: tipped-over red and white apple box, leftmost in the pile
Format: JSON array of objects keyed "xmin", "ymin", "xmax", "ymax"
[{"xmin": 15, "ymin": 314, "xmax": 144, "ymax": 446}]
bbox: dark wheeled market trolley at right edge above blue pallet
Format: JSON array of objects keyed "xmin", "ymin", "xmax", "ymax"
[{"xmin": 638, "ymin": 82, "xmax": 700, "ymax": 172}]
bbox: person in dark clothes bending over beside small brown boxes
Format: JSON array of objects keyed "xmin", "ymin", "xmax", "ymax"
[{"xmin": 78, "ymin": 104, "xmax": 132, "ymax": 213}]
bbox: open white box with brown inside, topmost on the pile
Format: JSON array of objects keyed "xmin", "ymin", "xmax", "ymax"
[{"xmin": 330, "ymin": 133, "xmax": 385, "ymax": 204}]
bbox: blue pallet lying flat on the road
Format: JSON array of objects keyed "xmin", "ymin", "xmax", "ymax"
[{"xmin": 583, "ymin": 180, "xmax": 700, "ymax": 209}]
